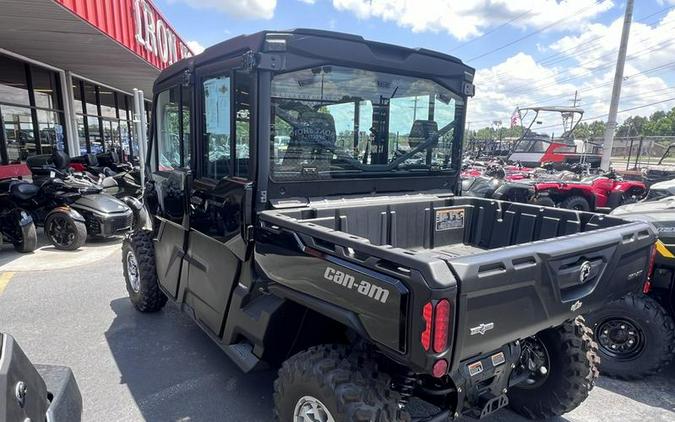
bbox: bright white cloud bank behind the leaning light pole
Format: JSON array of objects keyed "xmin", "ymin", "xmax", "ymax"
[{"xmin": 468, "ymin": 8, "xmax": 675, "ymax": 128}]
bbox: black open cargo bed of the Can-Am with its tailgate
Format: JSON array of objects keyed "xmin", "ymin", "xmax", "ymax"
[{"xmin": 257, "ymin": 195, "xmax": 655, "ymax": 372}]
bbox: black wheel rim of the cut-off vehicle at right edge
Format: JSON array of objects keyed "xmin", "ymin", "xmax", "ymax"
[{"xmin": 595, "ymin": 318, "xmax": 645, "ymax": 360}]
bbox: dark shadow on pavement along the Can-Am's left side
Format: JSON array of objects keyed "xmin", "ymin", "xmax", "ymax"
[{"xmin": 105, "ymin": 298, "xmax": 276, "ymax": 422}]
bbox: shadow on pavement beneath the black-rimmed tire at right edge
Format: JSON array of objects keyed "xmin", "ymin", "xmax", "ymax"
[{"xmin": 597, "ymin": 364, "xmax": 675, "ymax": 412}]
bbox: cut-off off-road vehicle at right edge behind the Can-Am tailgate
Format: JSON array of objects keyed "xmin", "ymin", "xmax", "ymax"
[{"xmin": 588, "ymin": 196, "xmax": 675, "ymax": 379}]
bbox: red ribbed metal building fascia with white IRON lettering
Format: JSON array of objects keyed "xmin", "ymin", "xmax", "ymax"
[{"xmin": 54, "ymin": 0, "xmax": 192, "ymax": 69}]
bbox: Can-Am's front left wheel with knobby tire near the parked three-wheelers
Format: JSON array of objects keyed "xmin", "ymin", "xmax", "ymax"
[{"xmin": 122, "ymin": 231, "xmax": 167, "ymax": 313}]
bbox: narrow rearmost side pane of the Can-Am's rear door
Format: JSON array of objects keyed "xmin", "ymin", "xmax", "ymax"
[{"xmin": 234, "ymin": 72, "xmax": 251, "ymax": 179}]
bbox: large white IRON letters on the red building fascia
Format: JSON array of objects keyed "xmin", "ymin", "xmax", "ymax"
[{"xmin": 134, "ymin": 0, "xmax": 192, "ymax": 65}]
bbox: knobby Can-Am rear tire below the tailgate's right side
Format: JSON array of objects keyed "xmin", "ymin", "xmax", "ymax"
[{"xmin": 508, "ymin": 317, "xmax": 598, "ymax": 419}]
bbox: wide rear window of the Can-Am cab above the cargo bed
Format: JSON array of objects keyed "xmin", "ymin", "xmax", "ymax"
[{"xmin": 271, "ymin": 66, "xmax": 464, "ymax": 179}]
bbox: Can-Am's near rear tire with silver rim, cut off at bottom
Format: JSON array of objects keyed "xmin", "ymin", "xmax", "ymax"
[{"xmin": 274, "ymin": 345, "xmax": 410, "ymax": 422}]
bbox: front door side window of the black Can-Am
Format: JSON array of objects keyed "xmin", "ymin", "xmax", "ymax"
[{"xmin": 155, "ymin": 87, "xmax": 181, "ymax": 170}]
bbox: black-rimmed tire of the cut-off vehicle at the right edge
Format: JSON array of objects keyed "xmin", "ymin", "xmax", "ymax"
[{"xmin": 588, "ymin": 294, "xmax": 675, "ymax": 380}]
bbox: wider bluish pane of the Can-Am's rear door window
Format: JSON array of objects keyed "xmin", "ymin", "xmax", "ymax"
[{"xmin": 202, "ymin": 76, "xmax": 231, "ymax": 179}]
